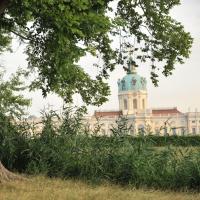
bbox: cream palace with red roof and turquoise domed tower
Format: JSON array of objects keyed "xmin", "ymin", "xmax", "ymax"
[{"xmin": 87, "ymin": 56, "xmax": 200, "ymax": 135}]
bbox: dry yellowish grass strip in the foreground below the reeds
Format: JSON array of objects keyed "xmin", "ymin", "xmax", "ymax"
[{"xmin": 0, "ymin": 177, "xmax": 200, "ymax": 200}]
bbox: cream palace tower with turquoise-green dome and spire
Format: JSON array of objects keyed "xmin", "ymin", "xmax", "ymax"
[{"xmin": 118, "ymin": 56, "xmax": 147, "ymax": 115}]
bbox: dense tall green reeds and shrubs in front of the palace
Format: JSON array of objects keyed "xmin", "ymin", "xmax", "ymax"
[{"xmin": 0, "ymin": 108, "xmax": 200, "ymax": 190}]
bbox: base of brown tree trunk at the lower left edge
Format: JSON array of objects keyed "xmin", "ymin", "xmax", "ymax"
[{"xmin": 0, "ymin": 161, "xmax": 23, "ymax": 183}]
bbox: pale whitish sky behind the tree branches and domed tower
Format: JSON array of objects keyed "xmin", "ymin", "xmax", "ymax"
[{"xmin": 0, "ymin": 0, "xmax": 200, "ymax": 115}]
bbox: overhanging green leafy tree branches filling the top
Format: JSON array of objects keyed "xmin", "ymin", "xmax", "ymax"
[{"xmin": 0, "ymin": 0, "xmax": 192, "ymax": 105}]
